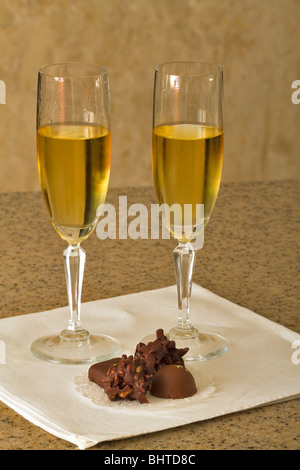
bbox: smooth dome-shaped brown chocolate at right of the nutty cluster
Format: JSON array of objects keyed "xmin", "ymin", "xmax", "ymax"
[{"xmin": 150, "ymin": 364, "xmax": 197, "ymax": 399}]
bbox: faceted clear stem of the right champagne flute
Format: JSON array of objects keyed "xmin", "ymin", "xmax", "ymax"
[{"xmin": 173, "ymin": 243, "xmax": 196, "ymax": 331}]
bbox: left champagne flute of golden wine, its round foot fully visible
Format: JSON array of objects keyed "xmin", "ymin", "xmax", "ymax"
[{"xmin": 31, "ymin": 63, "xmax": 119, "ymax": 364}]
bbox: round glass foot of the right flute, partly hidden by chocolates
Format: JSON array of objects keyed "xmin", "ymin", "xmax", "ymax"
[{"xmin": 168, "ymin": 327, "xmax": 229, "ymax": 362}]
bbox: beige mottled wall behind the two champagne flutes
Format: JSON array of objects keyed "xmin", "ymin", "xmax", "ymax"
[{"xmin": 0, "ymin": 0, "xmax": 300, "ymax": 191}]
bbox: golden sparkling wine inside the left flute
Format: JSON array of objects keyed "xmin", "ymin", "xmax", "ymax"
[{"xmin": 37, "ymin": 123, "xmax": 111, "ymax": 244}]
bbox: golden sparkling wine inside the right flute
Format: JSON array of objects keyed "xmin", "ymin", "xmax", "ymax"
[{"xmin": 152, "ymin": 124, "xmax": 224, "ymax": 242}]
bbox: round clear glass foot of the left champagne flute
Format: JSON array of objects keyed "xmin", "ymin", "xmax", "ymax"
[{"xmin": 30, "ymin": 335, "xmax": 120, "ymax": 364}]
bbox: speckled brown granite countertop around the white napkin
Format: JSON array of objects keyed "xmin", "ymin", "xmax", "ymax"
[{"xmin": 0, "ymin": 181, "xmax": 300, "ymax": 451}]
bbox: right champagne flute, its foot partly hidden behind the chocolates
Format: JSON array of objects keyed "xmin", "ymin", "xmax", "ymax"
[{"xmin": 152, "ymin": 62, "xmax": 228, "ymax": 361}]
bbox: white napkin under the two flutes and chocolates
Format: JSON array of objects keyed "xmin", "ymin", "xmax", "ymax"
[{"xmin": 0, "ymin": 284, "xmax": 300, "ymax": 449}]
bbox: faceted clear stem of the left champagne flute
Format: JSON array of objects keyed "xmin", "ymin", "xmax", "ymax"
[{"xmin": 60, "ymin": 244, "xmax": 89, "ymax": 341}]
